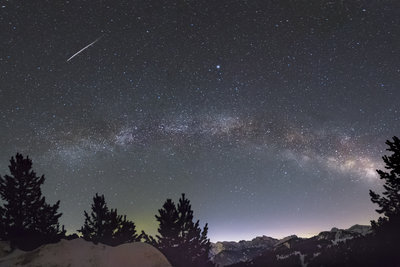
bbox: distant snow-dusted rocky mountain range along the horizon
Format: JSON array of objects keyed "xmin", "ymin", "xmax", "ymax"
[{"xmin": 212, "ymin": 225, "xmax": 371, "ymax": 266}]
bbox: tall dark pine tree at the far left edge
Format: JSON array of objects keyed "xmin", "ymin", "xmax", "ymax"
[{"xmin": 0, "ymin": 153, "xmax": 65, "ymax": 250}]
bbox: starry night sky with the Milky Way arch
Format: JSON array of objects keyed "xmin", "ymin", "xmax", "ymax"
[{"xmin": 0, "ymin": 0, "xmax": 400, "ymax": 241}]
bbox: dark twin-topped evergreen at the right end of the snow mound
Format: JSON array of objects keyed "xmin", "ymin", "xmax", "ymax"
[{"xmin": 152, "ymin": 194, "xmax": 212, "ymax": 267}]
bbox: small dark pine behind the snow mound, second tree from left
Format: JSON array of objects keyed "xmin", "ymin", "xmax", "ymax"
[{"xmin": 78, "ymin": 194, "xmax": 140, "ymax": 246}]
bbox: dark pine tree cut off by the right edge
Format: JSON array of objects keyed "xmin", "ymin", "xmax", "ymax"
[{"xmin": 369, "ymin": 136, "xmax": 400, "ymax": 238}]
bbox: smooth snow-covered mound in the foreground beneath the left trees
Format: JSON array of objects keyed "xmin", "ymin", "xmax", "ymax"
[{"xmin": 0, "ymin": 238, "xmax": 172, "ymax": 267}]
